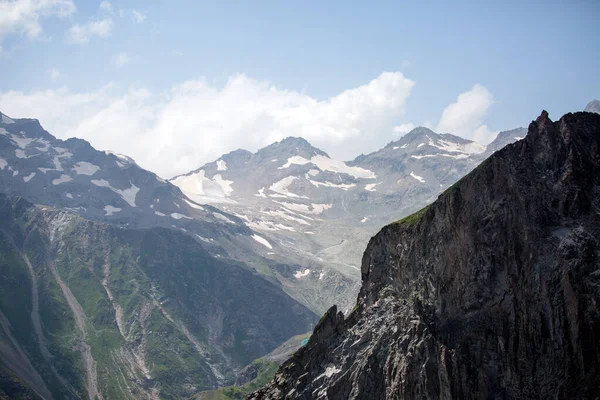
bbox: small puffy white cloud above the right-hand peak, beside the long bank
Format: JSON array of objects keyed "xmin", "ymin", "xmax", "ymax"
[{"xmin": 436, "ymin": 84, "xmax": 498, "ymax": 144}]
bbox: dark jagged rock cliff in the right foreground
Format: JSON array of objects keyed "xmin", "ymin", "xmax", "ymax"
[{"xmin": 249, "ymin": 112, "xmax": 600, "ymax": 400}]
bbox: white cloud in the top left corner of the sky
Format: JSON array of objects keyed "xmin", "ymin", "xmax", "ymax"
[{"xmin": 0, "ymin": 0, "xmax": 75, "ymax": 44}]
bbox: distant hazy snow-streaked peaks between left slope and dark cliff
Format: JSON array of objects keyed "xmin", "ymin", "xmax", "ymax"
[{"xmin": 170, "ymin": 128, "xmax": 526, "ymax": 314}]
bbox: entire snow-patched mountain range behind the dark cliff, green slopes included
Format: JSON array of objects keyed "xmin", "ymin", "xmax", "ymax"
[{"xmin": 0, "ymin": 103, "xmax": 592, "ymax": 399}]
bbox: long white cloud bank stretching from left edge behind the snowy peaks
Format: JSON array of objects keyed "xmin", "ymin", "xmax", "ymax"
[{"xmin": 0, "ymin": 72, "xmax": 414, "ymax": 177}]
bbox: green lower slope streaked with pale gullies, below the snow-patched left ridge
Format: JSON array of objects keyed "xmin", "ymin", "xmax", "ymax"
[{"xmin": 0, "ymin": 194, "xmax": 317, "ymax": 399}]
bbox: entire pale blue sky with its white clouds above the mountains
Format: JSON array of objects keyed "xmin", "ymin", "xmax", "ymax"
[{"xmin": 0, "ymin": 0, "xmax": 600, "ymax": 175}]
